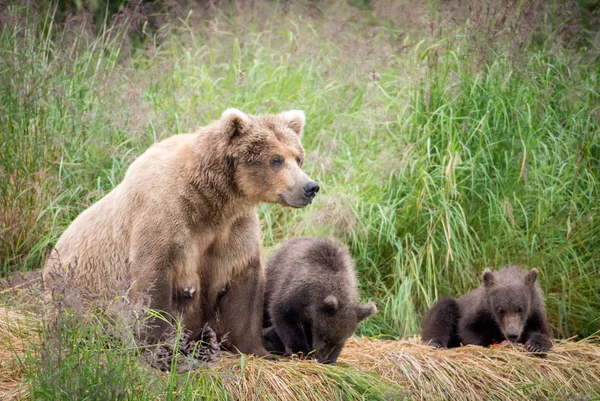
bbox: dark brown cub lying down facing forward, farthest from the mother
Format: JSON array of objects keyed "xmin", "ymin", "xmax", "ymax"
[{"xmin": 422, "ymin": 266, "xmax": 552, "ymax": 352}]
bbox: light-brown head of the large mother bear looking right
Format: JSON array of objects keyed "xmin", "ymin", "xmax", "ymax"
[{"xmin": 220, "ymin": 109, "xmax": 319, "ymax": 208}]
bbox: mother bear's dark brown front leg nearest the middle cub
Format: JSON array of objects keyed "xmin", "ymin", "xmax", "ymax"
[{"xmin": 217, "ymin": 256, "xmax": 270, "ymax": 356}]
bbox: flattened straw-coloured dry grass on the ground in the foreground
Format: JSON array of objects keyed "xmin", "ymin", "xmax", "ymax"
[{"xmin": 0, "ymin": 307, "xmax": 600, "ymax": 400}]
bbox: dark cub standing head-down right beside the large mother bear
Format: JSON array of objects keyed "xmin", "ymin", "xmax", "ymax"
[{"xmin": 263, "ymin": 237, "xmax": 377, "ymax": 363}]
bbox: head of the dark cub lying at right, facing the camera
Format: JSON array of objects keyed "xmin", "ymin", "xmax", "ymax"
[{"xmin": 482, "ymin": 268, "xmax": 538, "ymax": 342}]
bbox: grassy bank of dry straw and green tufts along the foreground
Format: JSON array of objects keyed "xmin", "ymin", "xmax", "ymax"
[{"xmin": 0, "ymin": 308, "xmax": 600, "ymax": 401}]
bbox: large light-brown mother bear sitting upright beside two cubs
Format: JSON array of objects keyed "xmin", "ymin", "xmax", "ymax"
[{"xmin": 44, "ymin": 109, "xmax": 319, "ymax": 355}]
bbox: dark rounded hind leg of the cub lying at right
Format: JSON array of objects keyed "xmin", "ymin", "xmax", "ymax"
[{"xmin": 421, "ymin": 298, "xmax": 459, "ymax": 348}]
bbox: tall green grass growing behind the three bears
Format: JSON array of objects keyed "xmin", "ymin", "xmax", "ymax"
[{"xmin": 0, "ymin": 3, "xmax": 600, "ymax": 346}]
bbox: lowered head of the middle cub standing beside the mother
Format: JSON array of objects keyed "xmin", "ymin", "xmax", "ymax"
[{"xmin": 311, "ymin": 295, "xmax": 377, "ymax": 363}]
